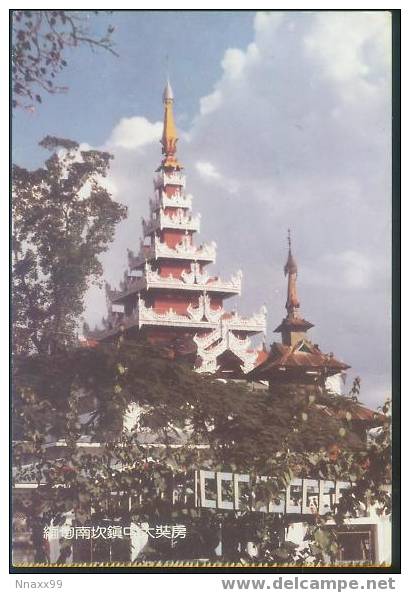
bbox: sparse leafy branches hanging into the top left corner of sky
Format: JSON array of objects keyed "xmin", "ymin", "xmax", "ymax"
[{"xmin": 11, "ymin": 10, "xmax": 116, "ymax": 109}]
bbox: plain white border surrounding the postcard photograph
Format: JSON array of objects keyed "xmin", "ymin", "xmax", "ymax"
[{"xmin": 0, "ymin": 0, "xmax": 410, "ymax": 593}]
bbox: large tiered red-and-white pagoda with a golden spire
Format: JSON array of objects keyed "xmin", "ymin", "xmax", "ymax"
[{"xmin": 88, "ymin": 81, "xmax": 266, "ymax": 377}]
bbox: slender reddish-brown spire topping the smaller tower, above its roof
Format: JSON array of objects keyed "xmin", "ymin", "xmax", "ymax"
[{"xmin": 275, "ymin": 229, "xmax": 313, "ymax": 346}]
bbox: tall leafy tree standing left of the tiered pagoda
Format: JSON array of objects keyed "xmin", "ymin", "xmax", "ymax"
[{"xmin": 12, "ymin": 136, "xmax": 126, "ymax": 353}]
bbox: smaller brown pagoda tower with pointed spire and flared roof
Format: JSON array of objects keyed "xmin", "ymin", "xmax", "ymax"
[{"xmin": 247, "ymin": 230, "xmax": 350, "ymax": 388}]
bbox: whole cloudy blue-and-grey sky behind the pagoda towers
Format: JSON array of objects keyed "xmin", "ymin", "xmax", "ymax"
[{"xmin": 13, "ymin": 11, "xmax": 391, "ymax": 406}]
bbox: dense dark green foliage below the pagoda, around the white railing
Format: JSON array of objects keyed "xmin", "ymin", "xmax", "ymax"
[{"xmin": 14, "ymin": 339, "xmax": 390, "ymax": 565}]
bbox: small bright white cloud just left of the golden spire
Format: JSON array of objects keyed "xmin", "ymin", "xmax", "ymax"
[{"xmin": 107, "ymin": 116, "xmax": 162, "ymax": 150}]
